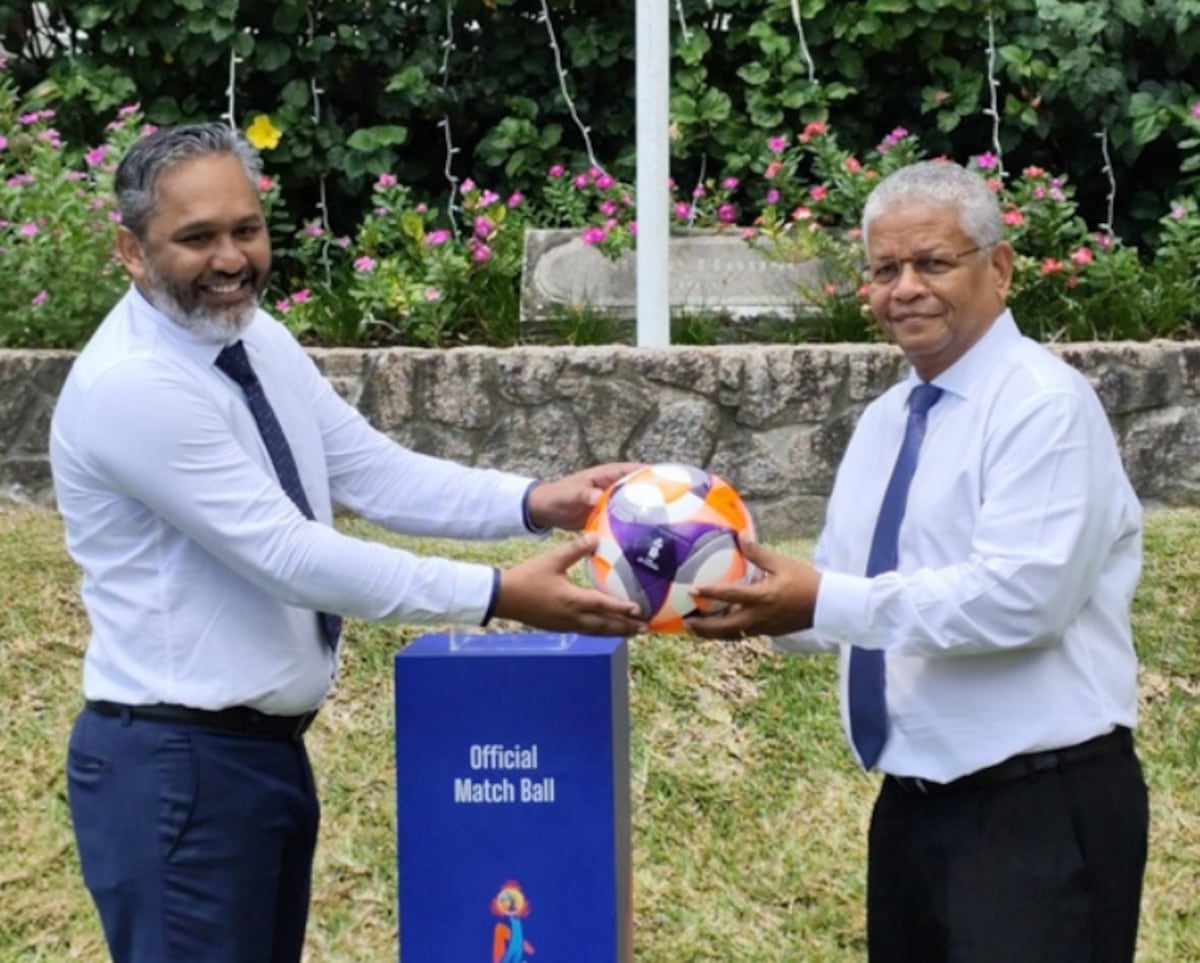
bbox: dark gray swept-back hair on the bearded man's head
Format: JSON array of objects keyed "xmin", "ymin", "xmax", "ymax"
[{"xmin": 113, "ymin": 124, "xmax": 263, "ymax": 240}]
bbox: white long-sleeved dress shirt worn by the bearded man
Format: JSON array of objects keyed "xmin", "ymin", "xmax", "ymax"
[{"xmin": 50, "ymin": 288, "xmax": 530, "ymax": 714}]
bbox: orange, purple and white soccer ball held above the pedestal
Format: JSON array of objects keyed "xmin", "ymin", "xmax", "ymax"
[{"xmin": 584, "ymin": 465, "xmax": 754, "ymax": 633}]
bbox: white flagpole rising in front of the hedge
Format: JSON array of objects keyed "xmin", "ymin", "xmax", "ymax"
[{"xmin": 637, "ymin": 0, "xmax": 671, "ymax": 347}]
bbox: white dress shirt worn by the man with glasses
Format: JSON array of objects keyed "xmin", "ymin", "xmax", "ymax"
[{"xmin": 775, "ymin": 311, "xmax": 1141, "ymax": 782}]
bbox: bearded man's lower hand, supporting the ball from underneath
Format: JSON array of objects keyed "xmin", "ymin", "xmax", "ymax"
[{"xmin": 494, "ymin": 536, "xmax": 646, "ymax": 635}]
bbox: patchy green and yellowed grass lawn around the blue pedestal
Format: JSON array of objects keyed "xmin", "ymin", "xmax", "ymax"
[{"xmin": 0, "ymin": 508, "xmax": 1200, "ymax": 963}]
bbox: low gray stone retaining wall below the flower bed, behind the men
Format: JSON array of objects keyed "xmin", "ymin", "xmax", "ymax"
[{"xmin": 0, "ymin": 341, "xmax": 1200, "ymax": 534}]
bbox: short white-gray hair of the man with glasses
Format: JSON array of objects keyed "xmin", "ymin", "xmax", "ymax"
[{"xmin": 863, "ymin": 161, "xmax": 1004, "ymax": 247}]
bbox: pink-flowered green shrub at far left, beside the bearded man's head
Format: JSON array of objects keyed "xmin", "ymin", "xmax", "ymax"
[{"xmin": 0, "ymin": 60, "xmax": 143, "ymax": 347}]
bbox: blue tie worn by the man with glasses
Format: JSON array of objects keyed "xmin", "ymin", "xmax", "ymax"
[{"xmin": 847, "ymin": 382, "xmax": 942, "ymax": 768}]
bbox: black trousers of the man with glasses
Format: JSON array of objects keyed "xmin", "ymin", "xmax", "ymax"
[{"xmin": 866, "ymin": 730, "xmax": 1148, "ymax": 963}]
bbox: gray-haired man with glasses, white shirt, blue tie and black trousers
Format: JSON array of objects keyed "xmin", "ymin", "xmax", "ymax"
[{"xmin": 692, "ymin": 161, "xmax": 1147, "ymax": 963}]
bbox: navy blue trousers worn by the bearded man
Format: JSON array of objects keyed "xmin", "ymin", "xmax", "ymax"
[{"xmin": 67, "ymin": 710, "xmax": 319, "ymax": 963}]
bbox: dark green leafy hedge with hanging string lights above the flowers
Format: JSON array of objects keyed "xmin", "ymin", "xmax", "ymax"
[{"xmin": 0, "ymin": 0, "xmax": 1200, "ymax": 256}]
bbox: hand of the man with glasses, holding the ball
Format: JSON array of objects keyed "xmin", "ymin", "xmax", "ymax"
[{"xmin": 686, "ymin": 542, "xmax": 821, "ymax": 639}]
